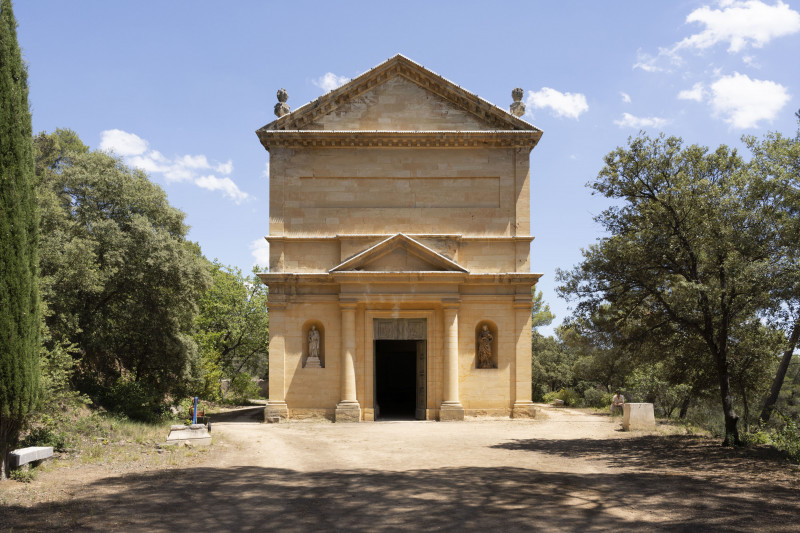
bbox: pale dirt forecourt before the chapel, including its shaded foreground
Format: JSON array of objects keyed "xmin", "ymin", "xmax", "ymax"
[{"xmin": 0, "ymin": 408, "xmax": 800, "ymax": 532}]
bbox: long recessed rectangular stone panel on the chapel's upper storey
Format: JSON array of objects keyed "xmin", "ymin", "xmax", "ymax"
[{"xmin": 298, "ymin": 177, "xmax": 500, "ymax": 209}]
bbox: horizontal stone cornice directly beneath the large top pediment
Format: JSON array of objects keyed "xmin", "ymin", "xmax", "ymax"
[{"xmin": 257, "ymin": 129, "xmax": 542, "ymax": 150}]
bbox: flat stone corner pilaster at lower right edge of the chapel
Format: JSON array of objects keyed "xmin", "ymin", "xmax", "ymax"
[{"xmin": 511, "ymin": 292, "xmax": 536, "ymax": 418}]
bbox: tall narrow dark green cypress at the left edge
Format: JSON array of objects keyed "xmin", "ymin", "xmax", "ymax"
[{"xmin": 0, "ymin": 0, "xmax": 40, "ymax": 477}]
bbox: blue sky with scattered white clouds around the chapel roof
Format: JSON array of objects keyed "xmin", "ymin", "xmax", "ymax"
[{"xmin": 15, "ymin": 0, "xmax": 800, "ymax": 332}]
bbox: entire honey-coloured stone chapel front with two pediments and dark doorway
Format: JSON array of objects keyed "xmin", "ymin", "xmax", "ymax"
[{"xmin": 257, "ymin": 55, "xmax": 542, "ymax": 422}]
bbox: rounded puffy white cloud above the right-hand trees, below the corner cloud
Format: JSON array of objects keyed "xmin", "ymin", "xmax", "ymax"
[{"xmin": 711, "ymin": 72, "xmax": 790, "ymax": 129}]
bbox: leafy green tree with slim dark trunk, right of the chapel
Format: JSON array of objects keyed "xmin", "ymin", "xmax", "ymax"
[{"xmin": 559, "ymin": 136, "xmax": 779, "ymax": 444}]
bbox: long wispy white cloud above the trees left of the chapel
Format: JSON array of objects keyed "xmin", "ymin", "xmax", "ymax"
[{"xmin": 100, "ymin": 130, "xmax": 250, "ymax": 204}]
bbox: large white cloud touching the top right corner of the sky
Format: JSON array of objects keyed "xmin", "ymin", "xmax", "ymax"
[{"xmin": 674, "ymin": 0, "xmax": 800, "ymax": 52}]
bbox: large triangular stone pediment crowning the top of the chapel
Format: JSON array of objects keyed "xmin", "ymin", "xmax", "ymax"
[{"xmin": 259, "ymin": 55, "xmax": 540, "ymax": 132}]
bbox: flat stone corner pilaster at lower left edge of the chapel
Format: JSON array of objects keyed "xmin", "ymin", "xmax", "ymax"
[{"xmin": 264, "ymin": 295, "xmax": 289, "ymax": 423}]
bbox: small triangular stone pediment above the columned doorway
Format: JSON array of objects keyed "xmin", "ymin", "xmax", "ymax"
[{"xmin": 330, "ymin": 233, "xmax": 468, "ymax": 273}]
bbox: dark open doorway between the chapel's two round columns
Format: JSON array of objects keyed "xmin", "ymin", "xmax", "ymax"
[{"xmin": 375, "ymin": 340, "xmax": 417, "ymax": 420}]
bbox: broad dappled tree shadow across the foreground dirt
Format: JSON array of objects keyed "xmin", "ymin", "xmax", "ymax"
[{"xmin": 0, "ymin": 460, "xmax": 800, "ymax": 532}]
